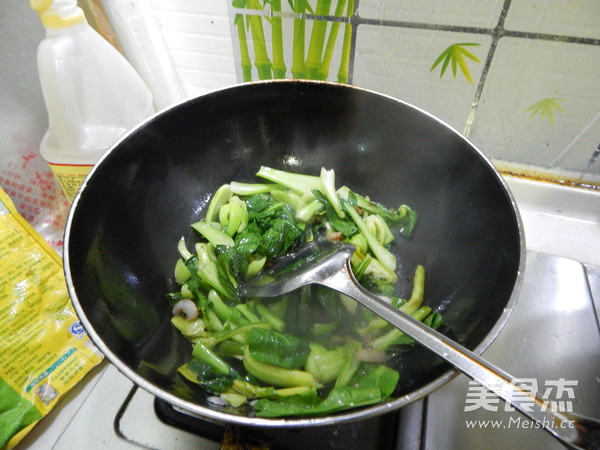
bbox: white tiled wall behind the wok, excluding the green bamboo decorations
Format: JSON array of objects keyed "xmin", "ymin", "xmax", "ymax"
[{"xmin": 142, "ymin": 0, "xmax": 600, "ymax": 184}]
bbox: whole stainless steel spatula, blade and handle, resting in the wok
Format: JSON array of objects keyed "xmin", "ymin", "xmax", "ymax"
[{"xmin": 238, "ymin": 241, "xmax": 600, "ymax": 449}]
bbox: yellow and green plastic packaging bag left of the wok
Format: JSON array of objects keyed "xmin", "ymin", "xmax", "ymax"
[{"xmin": 0, "ymin": 189, "xmax": 103, "ymax": 449}]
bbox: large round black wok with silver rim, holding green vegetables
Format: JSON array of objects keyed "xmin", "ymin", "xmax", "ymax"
[{"xmin": 64, "ymin": 80, "xmax": 525, "ymax": 427}]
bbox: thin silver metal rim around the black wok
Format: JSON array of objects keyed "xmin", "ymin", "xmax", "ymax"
[{"xmin": 63, "ymin": 79, "xmax": 526, "ymax": 428}]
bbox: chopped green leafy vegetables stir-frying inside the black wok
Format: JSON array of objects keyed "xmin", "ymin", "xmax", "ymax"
[{"xmin": 168, "ymin": 167, "xmax": 441, "ymax": 417}]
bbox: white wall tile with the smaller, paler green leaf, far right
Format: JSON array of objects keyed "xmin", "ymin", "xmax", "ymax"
[{"xmin": 471, "ymin": 38, "xmax": 600, "ymax": 171}]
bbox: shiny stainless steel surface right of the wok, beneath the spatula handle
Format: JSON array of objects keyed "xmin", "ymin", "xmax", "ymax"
[{"xmin": 420, "ymin": 252, "xmax": 600, "ymax": 450}]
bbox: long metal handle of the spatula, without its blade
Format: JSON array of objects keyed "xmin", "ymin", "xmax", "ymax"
[{"xmin": 318, "ymin": 261, "xmax": 600, "ymax": 450}]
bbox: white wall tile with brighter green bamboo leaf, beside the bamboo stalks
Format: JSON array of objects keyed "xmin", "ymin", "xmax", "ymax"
[{"xmin": 354, "ymin": 25, "xmax": 491, "ymax": 132}]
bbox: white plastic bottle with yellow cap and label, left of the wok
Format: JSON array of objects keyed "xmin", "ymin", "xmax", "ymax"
[{"xmin": 30, "ymin": 0, "xmax": 154, "ymax": 200}]
